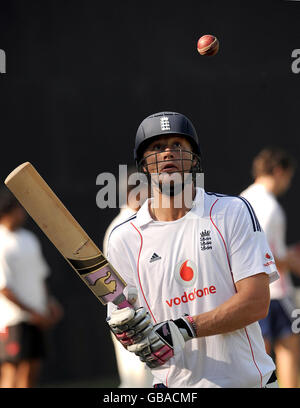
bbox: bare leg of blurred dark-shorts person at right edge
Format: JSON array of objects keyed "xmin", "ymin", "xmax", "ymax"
[{"xmin": 274, "ymin": 334, "xmax": 300, "ymax": 388}]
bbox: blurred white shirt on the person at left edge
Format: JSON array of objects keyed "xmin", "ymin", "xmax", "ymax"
[{"xmin": 0, "ymin": 225, "xmax": 49, "ymax": 327}]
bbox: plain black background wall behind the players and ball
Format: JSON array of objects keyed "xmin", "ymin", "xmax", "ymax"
[{"xmin": 0, "ymin": 0, "xmax": 300, "ymax": 385}]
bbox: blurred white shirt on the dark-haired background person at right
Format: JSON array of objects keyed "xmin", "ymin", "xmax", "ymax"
[{"xmin": 241, "ymin": 183, "xmax": 293, "ymax": 299}]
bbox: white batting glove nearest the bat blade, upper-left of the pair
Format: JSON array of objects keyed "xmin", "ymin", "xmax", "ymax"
[{"xmin": 106, "ymin": 307, "xmax": 153, "ymax": 348}]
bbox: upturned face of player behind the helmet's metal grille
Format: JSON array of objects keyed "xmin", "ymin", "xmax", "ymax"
[{"xmin": 143, "ymin": 135, "xmax": 193, "ymax": 174}]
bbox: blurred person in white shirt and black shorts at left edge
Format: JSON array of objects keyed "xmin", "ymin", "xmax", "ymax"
[{"xmin": 0, "ymin": 187, "xmax": 62, "ymax": 388}]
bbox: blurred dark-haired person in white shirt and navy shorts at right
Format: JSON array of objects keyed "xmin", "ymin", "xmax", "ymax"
[{"xmin": 241, "ymin": 147, "xmax": 300, "ymax": 388}]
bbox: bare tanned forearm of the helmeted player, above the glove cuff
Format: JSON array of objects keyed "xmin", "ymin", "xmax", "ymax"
[{"xmin": 193, "ymin": 293, "xmax": 269, "ymax": 337}]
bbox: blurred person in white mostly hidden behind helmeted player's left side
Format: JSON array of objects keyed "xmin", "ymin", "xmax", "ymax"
[{"xmin": 103, "ymin": 166, "xmax": 153, "ymax": 388}]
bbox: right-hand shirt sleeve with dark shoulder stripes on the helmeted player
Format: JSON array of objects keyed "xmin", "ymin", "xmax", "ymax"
[{"xmin": 228, "ymin": 201, "xmax": 279, "ymax": 283}]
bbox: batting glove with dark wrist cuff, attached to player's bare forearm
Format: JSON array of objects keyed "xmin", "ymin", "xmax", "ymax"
[{"xmin": 127, "ymin": 315, "xmax": 196, "ymax": 368}]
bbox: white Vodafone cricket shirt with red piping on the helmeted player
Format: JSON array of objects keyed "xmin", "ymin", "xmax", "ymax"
[{"xmin": 108, "ymin": 188, "xmax": 278, "ymax": 388}]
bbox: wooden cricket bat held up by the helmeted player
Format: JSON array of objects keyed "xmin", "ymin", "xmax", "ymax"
[{"xmin": 5, "ymin": 162, "xmax": 132, "ymax": 309}]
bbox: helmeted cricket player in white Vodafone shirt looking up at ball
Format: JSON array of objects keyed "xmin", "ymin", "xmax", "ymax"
[{"xmin": 107, "ymin": 112, "xmax": 278, "ymax": 388}]
